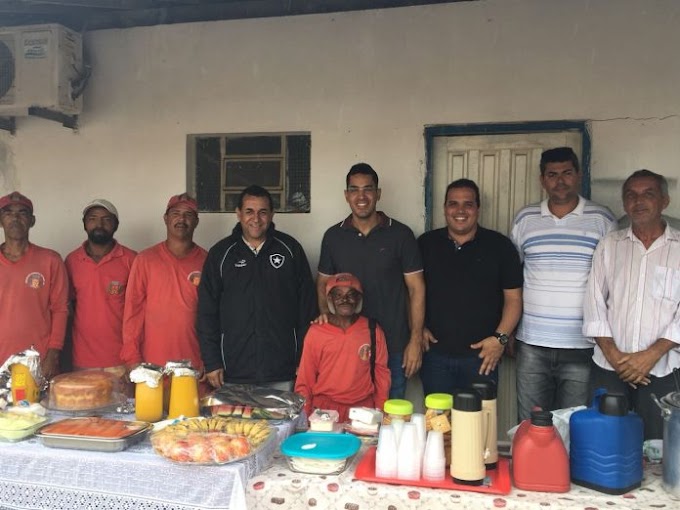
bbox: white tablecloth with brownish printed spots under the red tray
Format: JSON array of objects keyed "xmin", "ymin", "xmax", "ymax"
[{"xmin": 246, "ymin": 446, "xmax": 680, "ymax": 510}]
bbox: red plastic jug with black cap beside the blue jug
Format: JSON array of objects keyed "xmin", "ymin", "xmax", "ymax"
[{"xmin": 512, "ymin": 411, "xmax": 571, "ymax": 492}]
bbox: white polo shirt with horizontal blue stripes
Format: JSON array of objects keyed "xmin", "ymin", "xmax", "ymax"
[{"xmin": 511, "ymin": 197, "xmax": 616, "ymax": 349}]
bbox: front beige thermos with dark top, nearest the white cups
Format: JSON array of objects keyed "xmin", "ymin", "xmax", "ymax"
[{"xmin": 451, "ymin": 390, "xmax": 486, "ymax": 485}]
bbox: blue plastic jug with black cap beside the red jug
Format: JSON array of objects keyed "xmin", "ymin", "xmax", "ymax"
[{"xmin": 569, "ymin": 388, "xmax": 644, "ymax": 494}]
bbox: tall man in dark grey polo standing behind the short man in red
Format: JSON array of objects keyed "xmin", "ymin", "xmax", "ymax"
[{"xmin": 317, "ymin": 163, "xmax": 425, "ymax": 398}]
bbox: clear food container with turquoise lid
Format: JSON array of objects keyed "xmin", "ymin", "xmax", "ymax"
[{"xmin": 281, "ymin": 432, "xmax": 361, "ymax": 475}]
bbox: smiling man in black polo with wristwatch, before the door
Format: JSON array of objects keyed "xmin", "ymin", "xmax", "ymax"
[{"xmin": 418, "ymin": 179, "xmax": 522, "ymax": 395}]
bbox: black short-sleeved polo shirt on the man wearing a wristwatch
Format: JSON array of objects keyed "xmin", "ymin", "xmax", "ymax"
[{"xmin": 418, "ymin": 227, "xmax": 523, "ymax": 356}]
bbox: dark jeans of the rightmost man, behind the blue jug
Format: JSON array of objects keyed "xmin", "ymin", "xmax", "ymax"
[{"xmin": 590, "ymin": 363, "xmax": 676, "ymax": 439}]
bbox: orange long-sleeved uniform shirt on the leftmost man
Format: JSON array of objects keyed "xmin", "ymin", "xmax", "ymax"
[{"xmin": 0, "ymin": 244, "xmax": 68, "ymax": 365}]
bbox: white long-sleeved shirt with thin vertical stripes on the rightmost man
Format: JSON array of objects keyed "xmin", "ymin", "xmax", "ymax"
[{"xmin": 583, "ymin": 226, "xmax": 680, "ymax": 377}]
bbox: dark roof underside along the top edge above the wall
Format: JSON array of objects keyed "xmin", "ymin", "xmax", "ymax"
[{"xmin": 0, "ymin": 0, "xmax": 477, "ymax": 31}]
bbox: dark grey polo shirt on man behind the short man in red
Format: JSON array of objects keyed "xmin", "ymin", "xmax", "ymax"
[{"xmin": 319, "ymin": 212, "xmax": 423, "ymax": 354}]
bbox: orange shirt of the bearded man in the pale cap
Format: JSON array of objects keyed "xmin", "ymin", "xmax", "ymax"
[{"xmin": 66, "ymin": 243, "xmax": 137, "ymax": 368}]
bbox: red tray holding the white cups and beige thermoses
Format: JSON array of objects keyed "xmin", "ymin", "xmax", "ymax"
[{"xmin": 354, "ymin": 446, "xmax": 512, "ymax": 495}]
